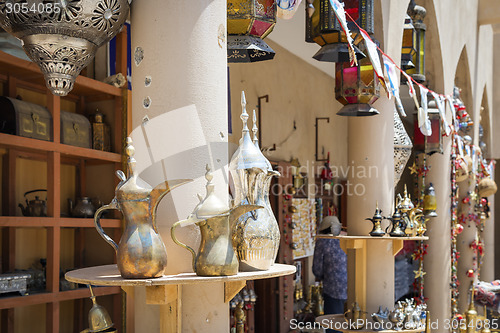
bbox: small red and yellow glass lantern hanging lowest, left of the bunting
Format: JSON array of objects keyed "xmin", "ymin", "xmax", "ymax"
[{"xmin": 335, "ymin": 58, "xmax": 380, "ymax": 117}]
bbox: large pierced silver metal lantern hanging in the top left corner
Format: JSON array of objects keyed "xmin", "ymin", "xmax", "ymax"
[{"xmin": 0, "ymin": 0, "xmax": 131, "ymax": 96}]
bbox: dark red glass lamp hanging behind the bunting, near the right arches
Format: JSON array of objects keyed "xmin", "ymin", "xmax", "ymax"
[{"xmin": 413, "ymin": 100, "xmax": 443, "ymax": 155}]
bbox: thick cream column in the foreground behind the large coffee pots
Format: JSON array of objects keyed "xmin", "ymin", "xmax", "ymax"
[{"xmin": 131, "ymin": 0, "xmax": 229, "ymax": 332}]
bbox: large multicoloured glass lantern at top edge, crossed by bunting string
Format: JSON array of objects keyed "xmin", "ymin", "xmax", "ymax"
[{"xmin": 306, "ymin": 0, "xmax": 373, "ymax": 62}]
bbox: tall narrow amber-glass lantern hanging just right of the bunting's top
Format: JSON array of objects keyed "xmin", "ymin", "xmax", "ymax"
[{"xmin": 406, "ymin": 1, "xmax": 427, "ymax": 82}]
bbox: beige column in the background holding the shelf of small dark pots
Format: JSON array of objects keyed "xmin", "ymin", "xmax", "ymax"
[{"xmin": 345, "ymin": 96, "xmax": 394, "ymax": 313}]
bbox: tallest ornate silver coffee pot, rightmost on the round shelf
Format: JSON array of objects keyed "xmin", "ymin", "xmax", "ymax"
[{"xmin": 229, "ymin": 93, "xmax": 280, "ymax": 271}]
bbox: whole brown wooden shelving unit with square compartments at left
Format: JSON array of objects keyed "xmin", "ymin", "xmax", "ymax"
[{"xmin": 0, "ymin": 29, "xmax": 130, "ymax": 333}]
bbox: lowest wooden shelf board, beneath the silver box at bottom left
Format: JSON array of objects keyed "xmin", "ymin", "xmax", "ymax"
[{"xmin": 0, "ymin": 287, "xmax": 121, "ymax": 310}]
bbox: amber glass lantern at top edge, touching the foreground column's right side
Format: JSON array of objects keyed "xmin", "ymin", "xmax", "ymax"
[{"xmin": 227, "ymin": 0, "xmax": 277, "ymax": 62}]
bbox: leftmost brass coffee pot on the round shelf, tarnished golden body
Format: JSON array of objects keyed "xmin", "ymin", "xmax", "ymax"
[{"xmin": 94, "ymin": 138, "xmax": 192, "ymax": 279}]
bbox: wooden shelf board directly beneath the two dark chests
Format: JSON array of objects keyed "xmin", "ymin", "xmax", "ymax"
[{"xmin": 0, "ymin": 133, "xmax": 121, "ymax": 163}]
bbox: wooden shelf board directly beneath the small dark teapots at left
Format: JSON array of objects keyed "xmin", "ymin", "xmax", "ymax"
[{"xmin": 0, "ymin": 216, "xmax": 121, "ymax": 228}]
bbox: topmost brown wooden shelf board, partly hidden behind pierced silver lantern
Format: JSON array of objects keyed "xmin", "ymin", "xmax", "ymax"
[{"xmin": 0, "ymin": 51, "xmax": 122, "ymax": 100}]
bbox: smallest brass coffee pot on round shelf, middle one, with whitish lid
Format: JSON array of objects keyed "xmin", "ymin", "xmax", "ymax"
[{"xmin": 171, "ymin": 165, "xmax": 263, "ymax": 276}]
